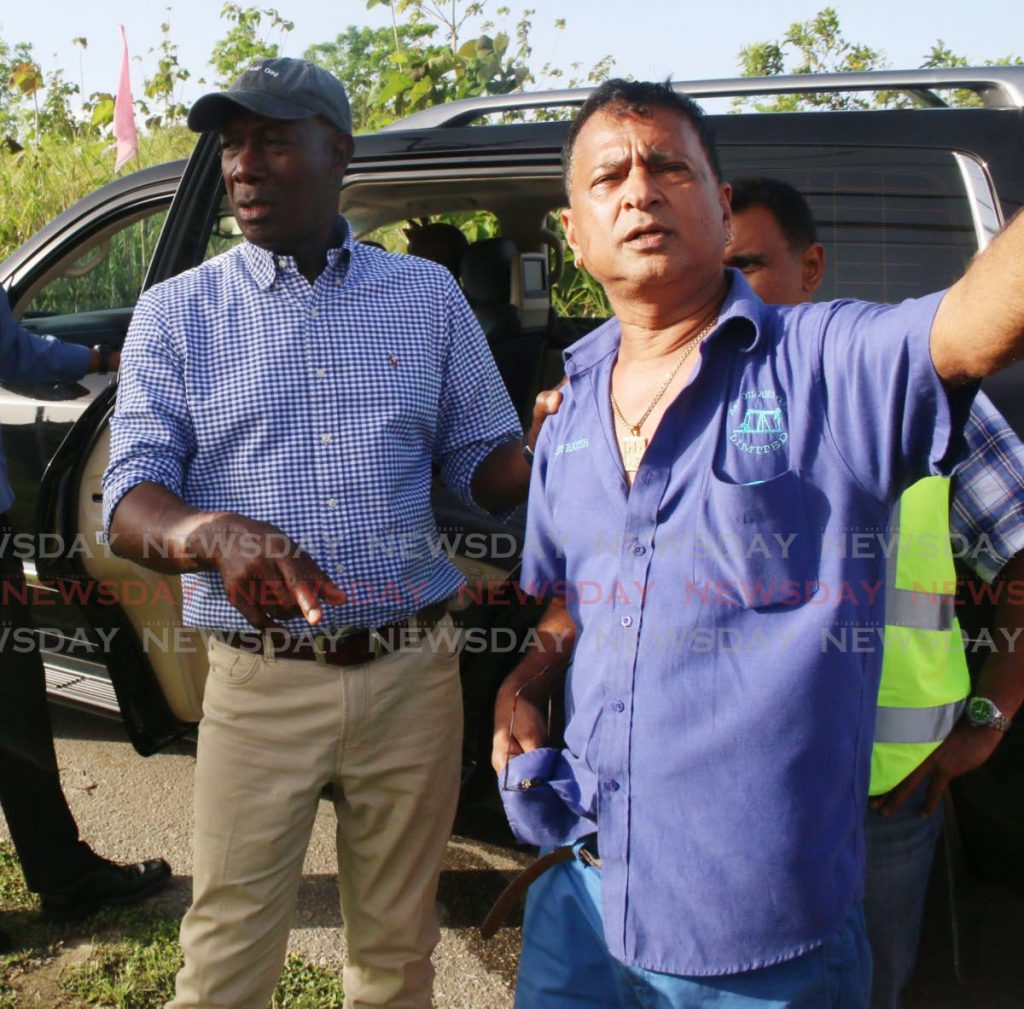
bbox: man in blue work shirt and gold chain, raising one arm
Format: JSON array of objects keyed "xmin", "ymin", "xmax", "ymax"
[{"xmin": 493, "ymin": 81, "xmax": 1024, "ymax": 1009}]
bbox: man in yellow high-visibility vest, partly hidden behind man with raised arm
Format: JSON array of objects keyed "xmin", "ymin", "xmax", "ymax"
[{"xmin": 725, "ymin": 178, "xmax": 1024, "ymax": 1009}]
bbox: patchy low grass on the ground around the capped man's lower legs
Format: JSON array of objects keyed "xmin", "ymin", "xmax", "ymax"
[{"xmin": 0, "ymin": 843, "xmax": 343, "ymax": 1009}]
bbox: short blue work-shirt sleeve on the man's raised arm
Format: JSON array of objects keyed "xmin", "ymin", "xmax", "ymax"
[{"xmin": 815, "ymin": 293, "xmax": 978, "ymax": 500}]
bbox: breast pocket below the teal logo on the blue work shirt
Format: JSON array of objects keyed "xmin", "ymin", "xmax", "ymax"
[{"xmin": 693, "ymin": 470, "xmax": 827, "ymax": 609}]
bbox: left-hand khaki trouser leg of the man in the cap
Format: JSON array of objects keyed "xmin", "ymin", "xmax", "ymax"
[{"xmin": 171, "ymin": 643, "xmax": 339, "ymax": 1009}]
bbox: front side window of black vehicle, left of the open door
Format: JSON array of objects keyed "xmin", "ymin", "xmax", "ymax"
[{"xmin": 19, "ymin": 205, "xmax": 167, "ymax": 320}]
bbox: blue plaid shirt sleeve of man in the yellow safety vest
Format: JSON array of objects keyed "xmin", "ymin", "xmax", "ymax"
[{"xmin": 949, "ymin": 392, "xmax": 1024, "ymax": 582}]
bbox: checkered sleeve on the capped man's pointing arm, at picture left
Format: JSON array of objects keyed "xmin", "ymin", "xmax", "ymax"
[{"xmin": 103, "ymin": 284, "xmax": 196, "ymax": 534}]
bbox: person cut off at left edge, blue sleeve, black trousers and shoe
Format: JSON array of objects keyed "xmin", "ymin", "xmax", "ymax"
[{"xmin": 0, "ymin": 291, "xmax": 171, "ymax": 944}]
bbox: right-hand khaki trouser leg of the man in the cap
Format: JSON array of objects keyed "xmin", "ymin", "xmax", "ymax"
[{"xmin": 335, "ymin": 620, "xmax": 462, "ymax": 1009}]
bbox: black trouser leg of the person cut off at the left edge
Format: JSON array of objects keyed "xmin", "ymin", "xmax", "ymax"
[{"xmin": 0, "ymin": 517, "xmax": 97, "ymax": 892}]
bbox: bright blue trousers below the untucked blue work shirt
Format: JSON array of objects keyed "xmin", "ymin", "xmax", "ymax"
[{"xmin": 515, "ymin": 844, "xmax": 871, "ymax": 1009}]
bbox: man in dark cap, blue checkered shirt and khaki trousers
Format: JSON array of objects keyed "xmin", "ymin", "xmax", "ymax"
[{"xmin": 104, "ymin": 59, "xmax": 529, "ymax": 1009}]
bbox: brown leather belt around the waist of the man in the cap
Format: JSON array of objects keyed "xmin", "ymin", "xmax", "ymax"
[{"xmin": 213, "ymin": 599, "xmax": 447, "ymax": 666}]
